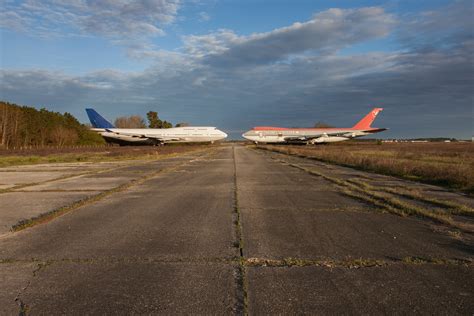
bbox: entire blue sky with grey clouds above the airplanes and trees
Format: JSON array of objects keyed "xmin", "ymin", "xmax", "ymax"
[{"xmin": 0, "ymin": 0, "xmax": 474, "ymax": 138}]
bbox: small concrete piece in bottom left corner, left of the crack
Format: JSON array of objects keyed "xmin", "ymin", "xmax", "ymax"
[{"xmin": 0, "ymin": 262, "xmax": 38, "ymax": 315}]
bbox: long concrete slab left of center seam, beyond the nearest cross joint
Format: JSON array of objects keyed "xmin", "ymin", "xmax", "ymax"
[{"xmin": 0, "ymin": 151, "xmax": 238, "ymax": 260}]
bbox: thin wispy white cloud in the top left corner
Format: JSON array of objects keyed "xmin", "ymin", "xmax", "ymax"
[{"xmin": 0, "ymin": 0, "xmax": 180, "ymax": 39}]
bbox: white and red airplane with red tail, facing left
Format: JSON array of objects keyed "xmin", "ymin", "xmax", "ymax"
[{"xmin": 242, "ymin": 108, "xmax": 387, "ymax": 144}]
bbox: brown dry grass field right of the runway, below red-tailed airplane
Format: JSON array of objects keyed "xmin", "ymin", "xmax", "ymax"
[{"xmin": 258, "ymin": 143, "xmax": 474, "ymax": 194}]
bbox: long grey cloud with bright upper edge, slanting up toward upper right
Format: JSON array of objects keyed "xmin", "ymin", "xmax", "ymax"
[{"xmin": 184, "ymin": 7, "xmax": 395, "ymax": 66}]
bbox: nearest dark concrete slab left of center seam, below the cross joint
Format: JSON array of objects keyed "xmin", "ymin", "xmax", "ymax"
[{"xmin": 21, "ymin": 262, "xmax": 236, "ymax": 315}]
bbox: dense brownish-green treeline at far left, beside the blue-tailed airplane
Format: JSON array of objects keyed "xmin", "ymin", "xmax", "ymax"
[{"xmin": 0, "ymin": 101, "xmax": 105, "ymax": 148}]
